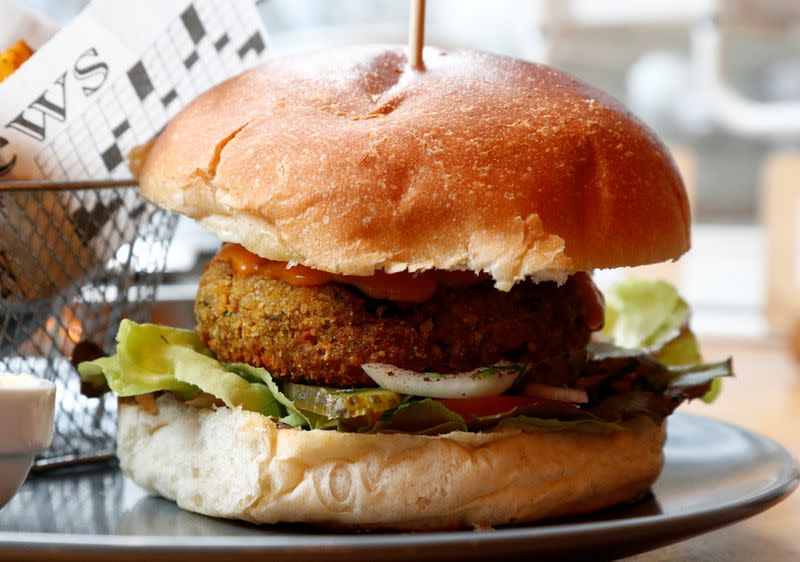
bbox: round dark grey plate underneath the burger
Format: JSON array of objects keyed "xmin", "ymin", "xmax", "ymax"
[{"xmin": 0, "ymin": 414, "xmax": 798, "ymax": 562}]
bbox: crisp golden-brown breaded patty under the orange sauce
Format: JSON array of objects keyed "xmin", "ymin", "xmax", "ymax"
[{"xmin": 195, "ymin": 256, "xmax": 591, "ymax": 387}]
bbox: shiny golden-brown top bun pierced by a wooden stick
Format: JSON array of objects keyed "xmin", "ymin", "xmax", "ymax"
[{"xmin": 140, "ymin": 46, "xmax": 689, "ymax": 290}]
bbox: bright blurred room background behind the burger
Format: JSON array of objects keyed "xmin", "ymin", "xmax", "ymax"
[{"xmin": 14, "ymin": 0, "xmax": 800, "ymax": 337}]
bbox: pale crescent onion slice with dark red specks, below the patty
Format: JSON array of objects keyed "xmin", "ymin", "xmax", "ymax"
[{"xmin": 361, "ymin": 363, "xmax": 525, "ymax": 398}]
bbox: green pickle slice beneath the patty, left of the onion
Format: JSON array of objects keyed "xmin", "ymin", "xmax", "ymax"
[{"xmin": 282, "ymin": 382, "xmax": 404, "ymax": 419}]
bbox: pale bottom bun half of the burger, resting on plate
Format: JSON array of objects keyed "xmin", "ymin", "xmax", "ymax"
[{"xmin": 117, "ymin": 395, "xmax": 665, "ymax": 530}]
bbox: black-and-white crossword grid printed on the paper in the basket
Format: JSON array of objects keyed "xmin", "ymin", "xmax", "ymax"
[{"xmin": 35, "ymin": 0, "xmax": 266, "ymax": 180}]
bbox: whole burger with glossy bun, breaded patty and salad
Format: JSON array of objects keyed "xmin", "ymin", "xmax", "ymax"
[{"xmin": 80, "ymin": 46, "xmax": 730, "ymax": 530}]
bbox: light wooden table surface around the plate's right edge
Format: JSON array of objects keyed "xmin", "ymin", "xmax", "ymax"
[{"xmin": 625, "ymin": 340, "xmax": 800, "ymax": 562}]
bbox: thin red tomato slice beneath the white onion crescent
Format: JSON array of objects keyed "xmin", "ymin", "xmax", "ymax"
[{"xmin": 437, "ymin": 395, "xmax": 587, "ymax": 420}]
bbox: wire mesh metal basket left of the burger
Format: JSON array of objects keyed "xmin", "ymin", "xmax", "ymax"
[{"xmin": 0, "ymin": 182, "xmax": 176, "ymax": 468}]
